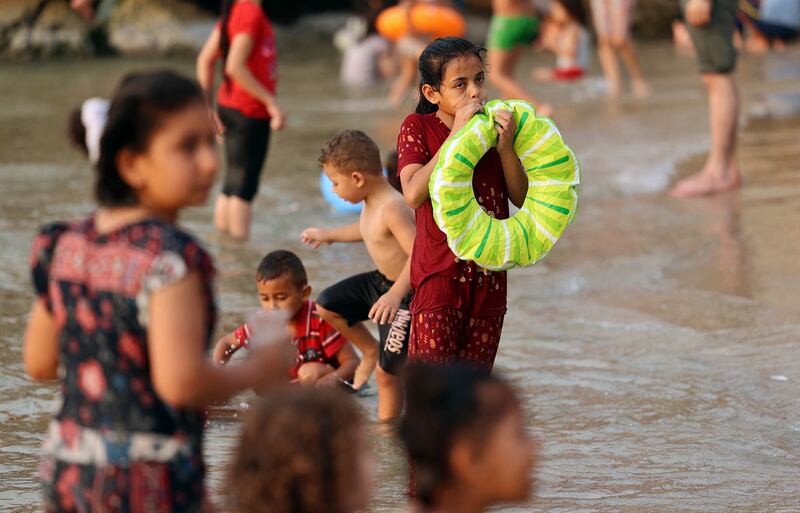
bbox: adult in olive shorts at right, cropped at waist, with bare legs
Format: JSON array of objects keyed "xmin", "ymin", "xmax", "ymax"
[{"xmin": 670, "ymin": 0, "xmax": 741, "ymax": 198}]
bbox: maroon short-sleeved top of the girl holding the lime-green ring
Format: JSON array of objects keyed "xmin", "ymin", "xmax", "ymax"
[{"xmin": 397, "ymin": 113, "xmax": 508, "ymax": 315}]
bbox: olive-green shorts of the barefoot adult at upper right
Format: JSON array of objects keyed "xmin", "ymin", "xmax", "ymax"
[{"xmin": 681, "ymin": 0, "xmax": 738, "ymax": 74}]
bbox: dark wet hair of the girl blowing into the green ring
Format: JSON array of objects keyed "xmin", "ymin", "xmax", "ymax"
[{"xmin": 416, "ymin": 37, "xmax": 486, "ymax": 114}]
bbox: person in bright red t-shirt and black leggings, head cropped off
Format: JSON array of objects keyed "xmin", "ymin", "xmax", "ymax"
[{"xmin": 197, "ymin": 0, "xmax": 285, "ymax": 240}]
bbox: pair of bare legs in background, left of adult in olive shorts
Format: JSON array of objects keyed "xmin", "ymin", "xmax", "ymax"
[{"xmin": 591, "ymin": 0, "xmax": 650, "ymax": 98}]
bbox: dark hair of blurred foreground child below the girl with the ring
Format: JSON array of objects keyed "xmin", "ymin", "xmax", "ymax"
[{"xmin": 399, "ymin": 363, "xmax": 520, "ymax": 507}]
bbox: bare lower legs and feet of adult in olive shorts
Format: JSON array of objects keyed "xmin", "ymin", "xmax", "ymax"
[{"xmin": 670, "ymin": 73, "xmax": 741, "ymax": 197}]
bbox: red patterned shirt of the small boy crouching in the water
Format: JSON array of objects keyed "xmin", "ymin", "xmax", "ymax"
[{"xmin": 233, "ymin": 301, "xmax": 347, "ymax": 379}]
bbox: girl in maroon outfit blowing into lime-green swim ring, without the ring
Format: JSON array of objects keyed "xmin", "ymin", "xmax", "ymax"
[{"xmin": 397, "ymin": 37, "xmax": 528, "ymax": 369}]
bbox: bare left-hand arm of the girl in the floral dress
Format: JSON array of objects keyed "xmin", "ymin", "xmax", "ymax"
[{"xmin": 22, "ymin": 298, "xmax": 59, "ymax": 380}]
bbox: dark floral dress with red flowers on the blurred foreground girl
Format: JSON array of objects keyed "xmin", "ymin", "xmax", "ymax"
[{"xmin": 31, "ymin": 217, "xmax": 216, "ymax": 513}]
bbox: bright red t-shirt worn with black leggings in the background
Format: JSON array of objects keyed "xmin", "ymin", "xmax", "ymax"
[{"xmin": 217, "ymin": 0, "xmax": 278, "ymax": 119}]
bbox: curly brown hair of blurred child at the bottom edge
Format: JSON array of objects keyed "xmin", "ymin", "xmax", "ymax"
[{"xmin": 227, "ymin": 387, "xmax": 365, "ymax": 513}]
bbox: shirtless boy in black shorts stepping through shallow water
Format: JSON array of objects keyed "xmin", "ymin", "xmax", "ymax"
[{"xmin": 301, "ymin": 130, "xmax": 415, "ymax": 421}]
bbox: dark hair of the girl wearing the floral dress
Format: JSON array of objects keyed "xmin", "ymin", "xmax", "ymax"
[{"xmin": 95, "ymin": 70, "xmax": 204, "ymax": 207}]
